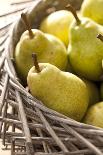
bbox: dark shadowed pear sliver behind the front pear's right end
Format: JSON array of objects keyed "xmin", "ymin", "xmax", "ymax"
[{"xmin": 82, "ymin": 78, "xmax": 100, "ymax": 106}]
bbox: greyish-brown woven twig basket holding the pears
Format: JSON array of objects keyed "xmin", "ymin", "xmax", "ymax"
[{"xmin": 0, "ymin": 0, "xmax": 103, "ymax": 155}]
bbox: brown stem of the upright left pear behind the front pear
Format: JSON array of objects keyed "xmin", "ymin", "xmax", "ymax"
[{"xmin": 21, "ymin": 13, "xmax": 34, "ymax": 39}]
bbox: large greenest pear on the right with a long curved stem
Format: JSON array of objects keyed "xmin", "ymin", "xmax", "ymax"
[{"xmin": 68, "ymin": 6, "xmax": 103, "ymax": 81}]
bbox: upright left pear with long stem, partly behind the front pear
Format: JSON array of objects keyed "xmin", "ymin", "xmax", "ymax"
[{"xmin": 15, "ymin": 14, "xmax": 68, "ymax": 82}]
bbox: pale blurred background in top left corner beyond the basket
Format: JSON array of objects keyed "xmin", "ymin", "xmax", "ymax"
[{"xmin": 0, "ymin": 0, "xmax": 35, "ymax": 28}]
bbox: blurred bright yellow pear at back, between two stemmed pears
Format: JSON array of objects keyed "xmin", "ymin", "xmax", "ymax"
[{"xmin": 40, "ymin": 10, "xmax": 73, "ymax": 46}]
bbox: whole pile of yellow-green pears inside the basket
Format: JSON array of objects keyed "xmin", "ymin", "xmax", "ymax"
[{"xmin": 14, "ymin": 0, "xmax": 103, "ymax": 128}]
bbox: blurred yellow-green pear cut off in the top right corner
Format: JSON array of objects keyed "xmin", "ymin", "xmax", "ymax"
[{"xmin": 81, "ymin": 0, "xmax": 103, "ymax": 25}]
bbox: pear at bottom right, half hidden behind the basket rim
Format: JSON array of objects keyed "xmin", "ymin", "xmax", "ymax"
[{"xmin": 83, "ymin": 102, "xmax": 103, "ymax": 128}]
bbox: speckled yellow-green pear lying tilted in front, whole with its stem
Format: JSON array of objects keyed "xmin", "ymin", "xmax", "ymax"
[{"xmin": 27, "ymin": 54, "xmax": 89, "ymax": 121}]
